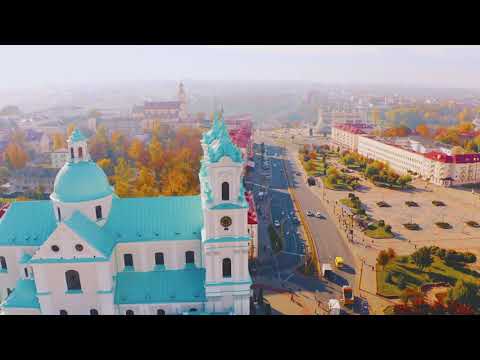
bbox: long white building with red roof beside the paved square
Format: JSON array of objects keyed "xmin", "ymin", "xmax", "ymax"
[{"xmin": 332, "ymin": 124, "xmax": 480, "ymax": 186}]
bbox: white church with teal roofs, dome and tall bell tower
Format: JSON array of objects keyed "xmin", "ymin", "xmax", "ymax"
[{"xmin": 0, "ymin": 117, "xmax": 252, "ymax": 315}]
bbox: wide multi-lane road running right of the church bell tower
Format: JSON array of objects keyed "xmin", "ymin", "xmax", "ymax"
[{"xmin": 254, "ymin": 131, "xmax": 364, "ymax": 312}]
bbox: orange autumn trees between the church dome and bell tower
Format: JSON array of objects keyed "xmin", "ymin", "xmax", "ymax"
[{"xmin": 89, "ymin": 126, "xmax": 202, "ymax": 197}]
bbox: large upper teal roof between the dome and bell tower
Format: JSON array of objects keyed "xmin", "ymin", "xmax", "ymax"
[{"xmin": 104, "ymin": 195, "xmax": 203, "ymax": 242}]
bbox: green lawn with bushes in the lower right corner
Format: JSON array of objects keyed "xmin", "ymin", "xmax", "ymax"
[{"xmin": 377, "ymin": 256, "xmax": 480, "ymax": 296}]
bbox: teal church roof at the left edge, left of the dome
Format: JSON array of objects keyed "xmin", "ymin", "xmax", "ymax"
[{"xmin": 0, "ymin": 200, "xmax": 57, "ymax": 246}]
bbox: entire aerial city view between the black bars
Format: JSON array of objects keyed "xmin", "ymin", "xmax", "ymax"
[{"xmin": 0, "ymin": 45, "xmax": 480, "ymax": 316}]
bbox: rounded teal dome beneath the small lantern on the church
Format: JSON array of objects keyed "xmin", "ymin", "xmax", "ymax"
[{"xmin": 50, "ymin": 161, "xmax": 113, "ymax": 202}]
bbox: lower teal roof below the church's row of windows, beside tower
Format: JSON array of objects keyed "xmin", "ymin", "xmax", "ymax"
[{"xmin": 115, "ymin": 268, "xmax": 206, "ymax": 304}]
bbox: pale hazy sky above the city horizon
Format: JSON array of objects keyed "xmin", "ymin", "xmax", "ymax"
[{"xmin": 0, "ymin": 45, "xmax": 480, "ymax": 89}]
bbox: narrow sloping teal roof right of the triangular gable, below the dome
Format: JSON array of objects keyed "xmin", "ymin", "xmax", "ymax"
[{"xmin": 65, "ymin": 211, "xmax": 115, "ymax": 258}]
